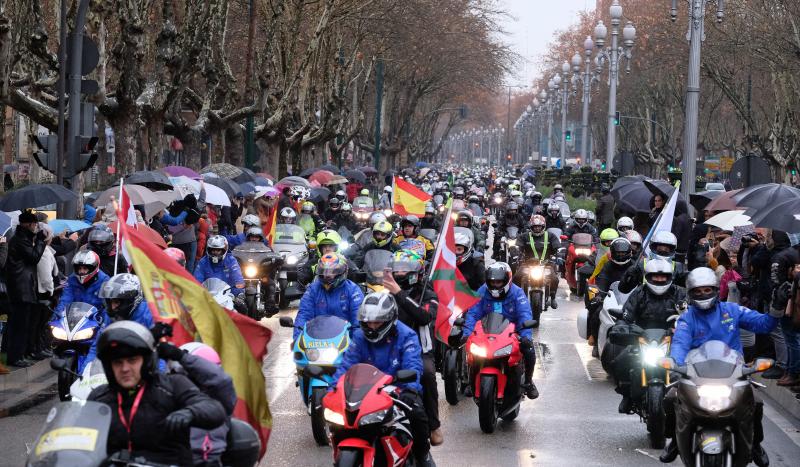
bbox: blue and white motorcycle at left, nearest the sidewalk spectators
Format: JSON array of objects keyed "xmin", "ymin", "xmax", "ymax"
[{"xmin": 48, "ymin": 302, "xmax": 104, "ymax": 401}]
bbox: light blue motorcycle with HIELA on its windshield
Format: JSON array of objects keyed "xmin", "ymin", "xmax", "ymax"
[{"xmin": 280, "ymin": 316, "xmax": 350, "ymax": 446}]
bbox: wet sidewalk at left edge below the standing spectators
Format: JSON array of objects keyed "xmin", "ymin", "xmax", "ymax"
[{"xmin": 0, "ymin": 358, "xmax": 57, "ymax": 418}]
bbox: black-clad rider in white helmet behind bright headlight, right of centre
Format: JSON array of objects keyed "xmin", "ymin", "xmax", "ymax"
[{"xmin": 614, "ymin": 262, "xmax": 686, "ymax": 414}]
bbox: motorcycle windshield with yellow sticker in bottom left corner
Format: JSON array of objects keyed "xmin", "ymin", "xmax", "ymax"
[{"xmin": 28, "ymin": 401, "xmax": 111, "ymax": 467}]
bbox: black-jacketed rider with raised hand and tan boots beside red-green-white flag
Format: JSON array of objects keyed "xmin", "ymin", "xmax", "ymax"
[{"xmin": 383, "ymin": 250, "xmax": 444, "ymax": 446}]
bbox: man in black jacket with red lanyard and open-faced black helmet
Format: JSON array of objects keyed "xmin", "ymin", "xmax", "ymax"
[{"xmin": 89, "ymin": 321, "xmax": 226, "ymax": 466}]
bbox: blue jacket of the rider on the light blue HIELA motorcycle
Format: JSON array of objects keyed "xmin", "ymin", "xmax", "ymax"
[{"xmin": 292, "ymin": 279, "xmax": 364, "ymax": 340}]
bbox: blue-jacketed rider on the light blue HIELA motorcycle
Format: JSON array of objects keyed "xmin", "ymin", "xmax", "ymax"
[{"xmin": 292, "ymin": 252, "xmax": 364, "ymax": 341}]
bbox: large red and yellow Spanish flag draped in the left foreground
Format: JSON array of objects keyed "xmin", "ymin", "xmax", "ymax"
[{"xmin": 119, "ymin": 222, "xmax": 272, "ymax": 456}]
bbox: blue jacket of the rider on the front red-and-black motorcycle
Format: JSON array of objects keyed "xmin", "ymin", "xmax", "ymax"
[{"xmin": 333, "ymin": 321, "xmax": 422, "ymax": 393}]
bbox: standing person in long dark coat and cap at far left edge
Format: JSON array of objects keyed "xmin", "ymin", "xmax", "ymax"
[{"xmin": 3, "ymin": 210, "xmax": 47, "ymax": 368}]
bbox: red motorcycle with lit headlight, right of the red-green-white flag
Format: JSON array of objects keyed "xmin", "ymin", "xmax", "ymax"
[{"xmin": 466, "ymin": 313, "xmax": 536, "ymax": 433}]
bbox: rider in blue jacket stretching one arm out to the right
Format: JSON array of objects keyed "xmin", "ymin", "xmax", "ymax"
[{"xmin": 659, "ymin": 268, "xmax": 784, "ymax": 467}]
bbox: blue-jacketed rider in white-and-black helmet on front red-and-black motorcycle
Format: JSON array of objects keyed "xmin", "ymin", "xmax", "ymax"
[{"xmin": 333, "ymin": 292, "xmax": 435, "ymax": 466}]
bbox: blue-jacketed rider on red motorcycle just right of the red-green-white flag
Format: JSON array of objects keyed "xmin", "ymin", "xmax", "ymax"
[{"xmin": 462, "ymin": 262, "xmax": 539, "ymax": 399}]
